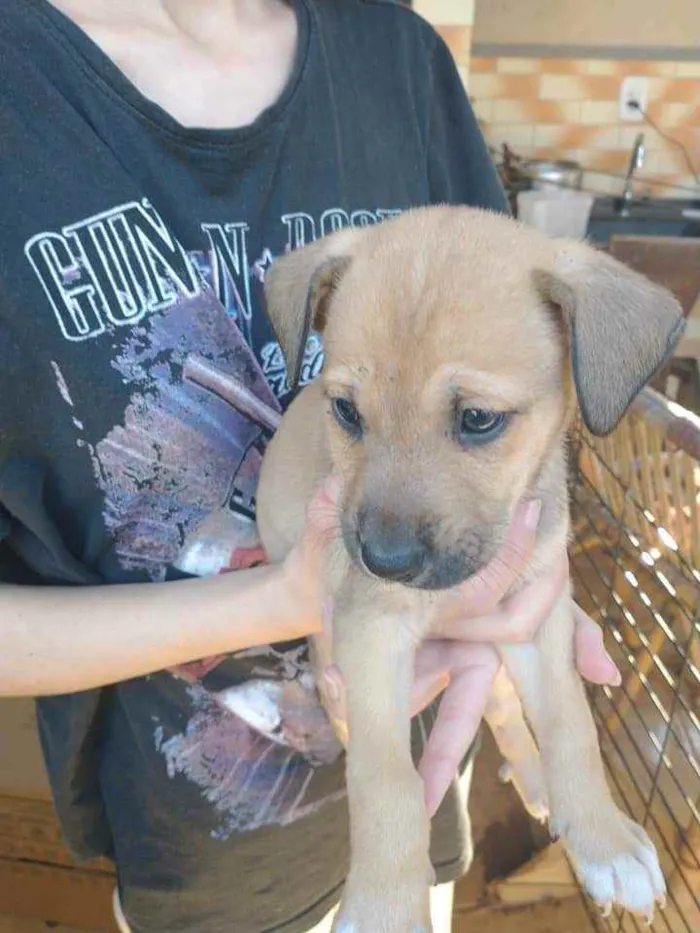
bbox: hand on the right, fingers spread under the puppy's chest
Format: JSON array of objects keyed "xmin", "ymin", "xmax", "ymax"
[{"xmin": 414, "ymin": 502, "xmax": 620, "ymax": 813}]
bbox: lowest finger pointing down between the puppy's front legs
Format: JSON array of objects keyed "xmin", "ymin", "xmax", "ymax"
[{"xmin": 418, "ymin": 645, "xmax": 500, "ymax": 816}]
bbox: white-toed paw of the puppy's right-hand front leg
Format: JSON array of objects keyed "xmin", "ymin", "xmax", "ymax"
[{"xmin": 564, "ymin": 809, "xmax": 666, "ymax": 923}]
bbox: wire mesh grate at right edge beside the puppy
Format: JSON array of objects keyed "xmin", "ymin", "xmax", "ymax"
[{"xmin": 571, "ymin": 389, "xmax": 700, "ymax": 933}]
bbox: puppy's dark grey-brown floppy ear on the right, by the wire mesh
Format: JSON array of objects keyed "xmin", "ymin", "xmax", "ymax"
[{"xmin": 534, "ymin": 243, "xmax": 685, "ymax": 436}]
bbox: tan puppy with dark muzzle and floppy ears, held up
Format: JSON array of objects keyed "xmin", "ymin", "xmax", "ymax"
[{"xmin": 258, "ymin": 207, "xmax": 683, "ymax": 933}]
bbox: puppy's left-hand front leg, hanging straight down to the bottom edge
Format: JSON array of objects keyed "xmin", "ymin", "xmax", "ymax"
[{"xmin": 333, "ymin": 570, "xmax": 433, "ymax": 933}]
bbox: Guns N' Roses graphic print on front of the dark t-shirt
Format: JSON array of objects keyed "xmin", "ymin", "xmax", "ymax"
[{"xmin": 26, "ymin": 202, "xmax": 400, "ymax": 839}]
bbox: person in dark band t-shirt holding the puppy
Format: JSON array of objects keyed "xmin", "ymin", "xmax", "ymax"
[{"xmin": 0, "ymin": 0, "xmax": 616, "ymax": 933}]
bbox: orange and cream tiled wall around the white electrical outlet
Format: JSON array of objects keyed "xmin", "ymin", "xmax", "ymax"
[{"xmin": 469, "ymin": 56, "xmax": 700, "ymax": 197}]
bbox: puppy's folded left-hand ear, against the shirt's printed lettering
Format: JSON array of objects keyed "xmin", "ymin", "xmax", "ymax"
[{"xmin": 265, "ymin": 230, "xmax": 359, "ymax": 388}]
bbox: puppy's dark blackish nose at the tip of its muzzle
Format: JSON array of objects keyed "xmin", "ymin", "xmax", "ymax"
[{"xmin": 357, "ymin": 511, "xmax": 425, "ymax": 583}]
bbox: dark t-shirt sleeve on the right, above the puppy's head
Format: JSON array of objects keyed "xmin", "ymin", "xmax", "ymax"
[{"xmin": 428, "ymin": 36, "xmax": 510, "ymax": 213}]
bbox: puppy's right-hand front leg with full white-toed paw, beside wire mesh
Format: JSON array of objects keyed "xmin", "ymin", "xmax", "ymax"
[{"xmin": 502, "ymin": 591, "xmax": 666, "ymax": 916}]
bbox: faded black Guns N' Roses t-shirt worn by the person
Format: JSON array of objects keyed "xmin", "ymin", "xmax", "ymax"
[{"xmin": 0, "ymin": 0, "xmax": 504, "ymax": 933}]
